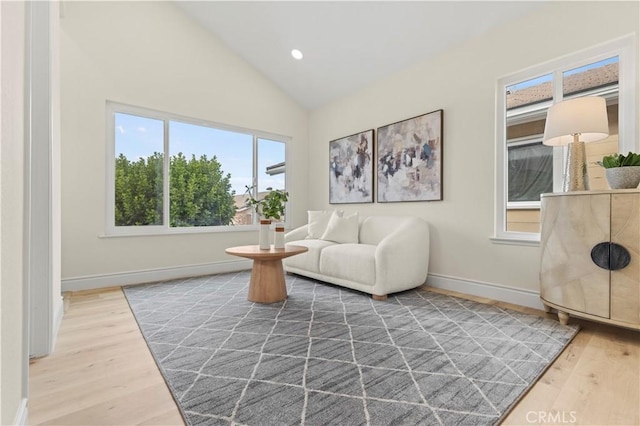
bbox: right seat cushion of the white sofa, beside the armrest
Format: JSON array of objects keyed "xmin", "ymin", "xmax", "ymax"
[{"xmin": 318, "ymin": 244, "xmax": 376, "ymax": 285}]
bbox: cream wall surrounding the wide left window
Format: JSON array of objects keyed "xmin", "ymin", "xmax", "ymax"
[{"xmin": 61, "ymin": 2, "xmax": 308, "ymax": 290}]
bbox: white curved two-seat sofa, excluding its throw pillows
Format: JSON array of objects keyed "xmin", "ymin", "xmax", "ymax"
[{"xmin": 283, "ymin": 212, "xmax": 429, "ymax": 300}]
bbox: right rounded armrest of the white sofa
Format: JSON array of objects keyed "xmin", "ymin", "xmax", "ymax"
[{"xmin": 375, "ymin": 218, "xmax": 429, "ymax": 294}]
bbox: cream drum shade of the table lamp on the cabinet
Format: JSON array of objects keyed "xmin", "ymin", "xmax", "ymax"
[{"xmin": 542, "ymin": 96, "xmax": 609, "ymax": 146}]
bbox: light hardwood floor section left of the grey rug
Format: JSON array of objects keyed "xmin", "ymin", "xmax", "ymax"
[{"xmin": 29, "ymin": 287, "xmax": 184, "ymax": 425}]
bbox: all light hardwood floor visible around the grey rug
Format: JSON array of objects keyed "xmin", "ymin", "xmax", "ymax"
[{"xmin": 29, "ymin": 288, "xmax": 640, "ymax": 425}]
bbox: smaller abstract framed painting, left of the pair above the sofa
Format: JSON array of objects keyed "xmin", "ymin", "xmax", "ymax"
[{"xmin": 329, "ymin": 129, "xmax": 374, "ymax": 204}]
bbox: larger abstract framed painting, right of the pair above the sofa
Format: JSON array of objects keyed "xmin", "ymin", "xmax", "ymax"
[{"xmin": 377, "ymin": 109, "xmax": 443, "ymax": 203}]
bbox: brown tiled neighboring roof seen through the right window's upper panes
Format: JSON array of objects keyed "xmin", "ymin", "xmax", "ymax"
[{"xmin": 507, "ymin": 63, "xmax": 618, "ymax": 109}]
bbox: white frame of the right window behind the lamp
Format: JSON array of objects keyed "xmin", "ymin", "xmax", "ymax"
[{"xmin": 490, "ymin": 35, "xmax": 640, "ymax": 246}]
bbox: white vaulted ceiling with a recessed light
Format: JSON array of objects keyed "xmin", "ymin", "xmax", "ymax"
[{"xmin": 177, "ymin": 1, "xmax": 542, "ymax": 109}]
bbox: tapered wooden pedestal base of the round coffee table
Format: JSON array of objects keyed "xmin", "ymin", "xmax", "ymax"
[{"xmin": 247, "ymin": 259, "xmax": 287, "ymax": 303}]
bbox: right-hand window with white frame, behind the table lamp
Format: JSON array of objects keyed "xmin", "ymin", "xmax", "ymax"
[{"xmin": 495, "ymin": 38, "xmax": 637, "ymax": 242}]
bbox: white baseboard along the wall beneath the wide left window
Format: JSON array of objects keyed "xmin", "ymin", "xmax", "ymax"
[{"xmin": 62, "ymin": 259, "xmax": 251, "ymax": 292}]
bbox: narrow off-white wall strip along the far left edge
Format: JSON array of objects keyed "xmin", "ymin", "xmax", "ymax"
[{"xmin": 0, "ymin": 2, "xmax": 28, "ymax": 425}]
